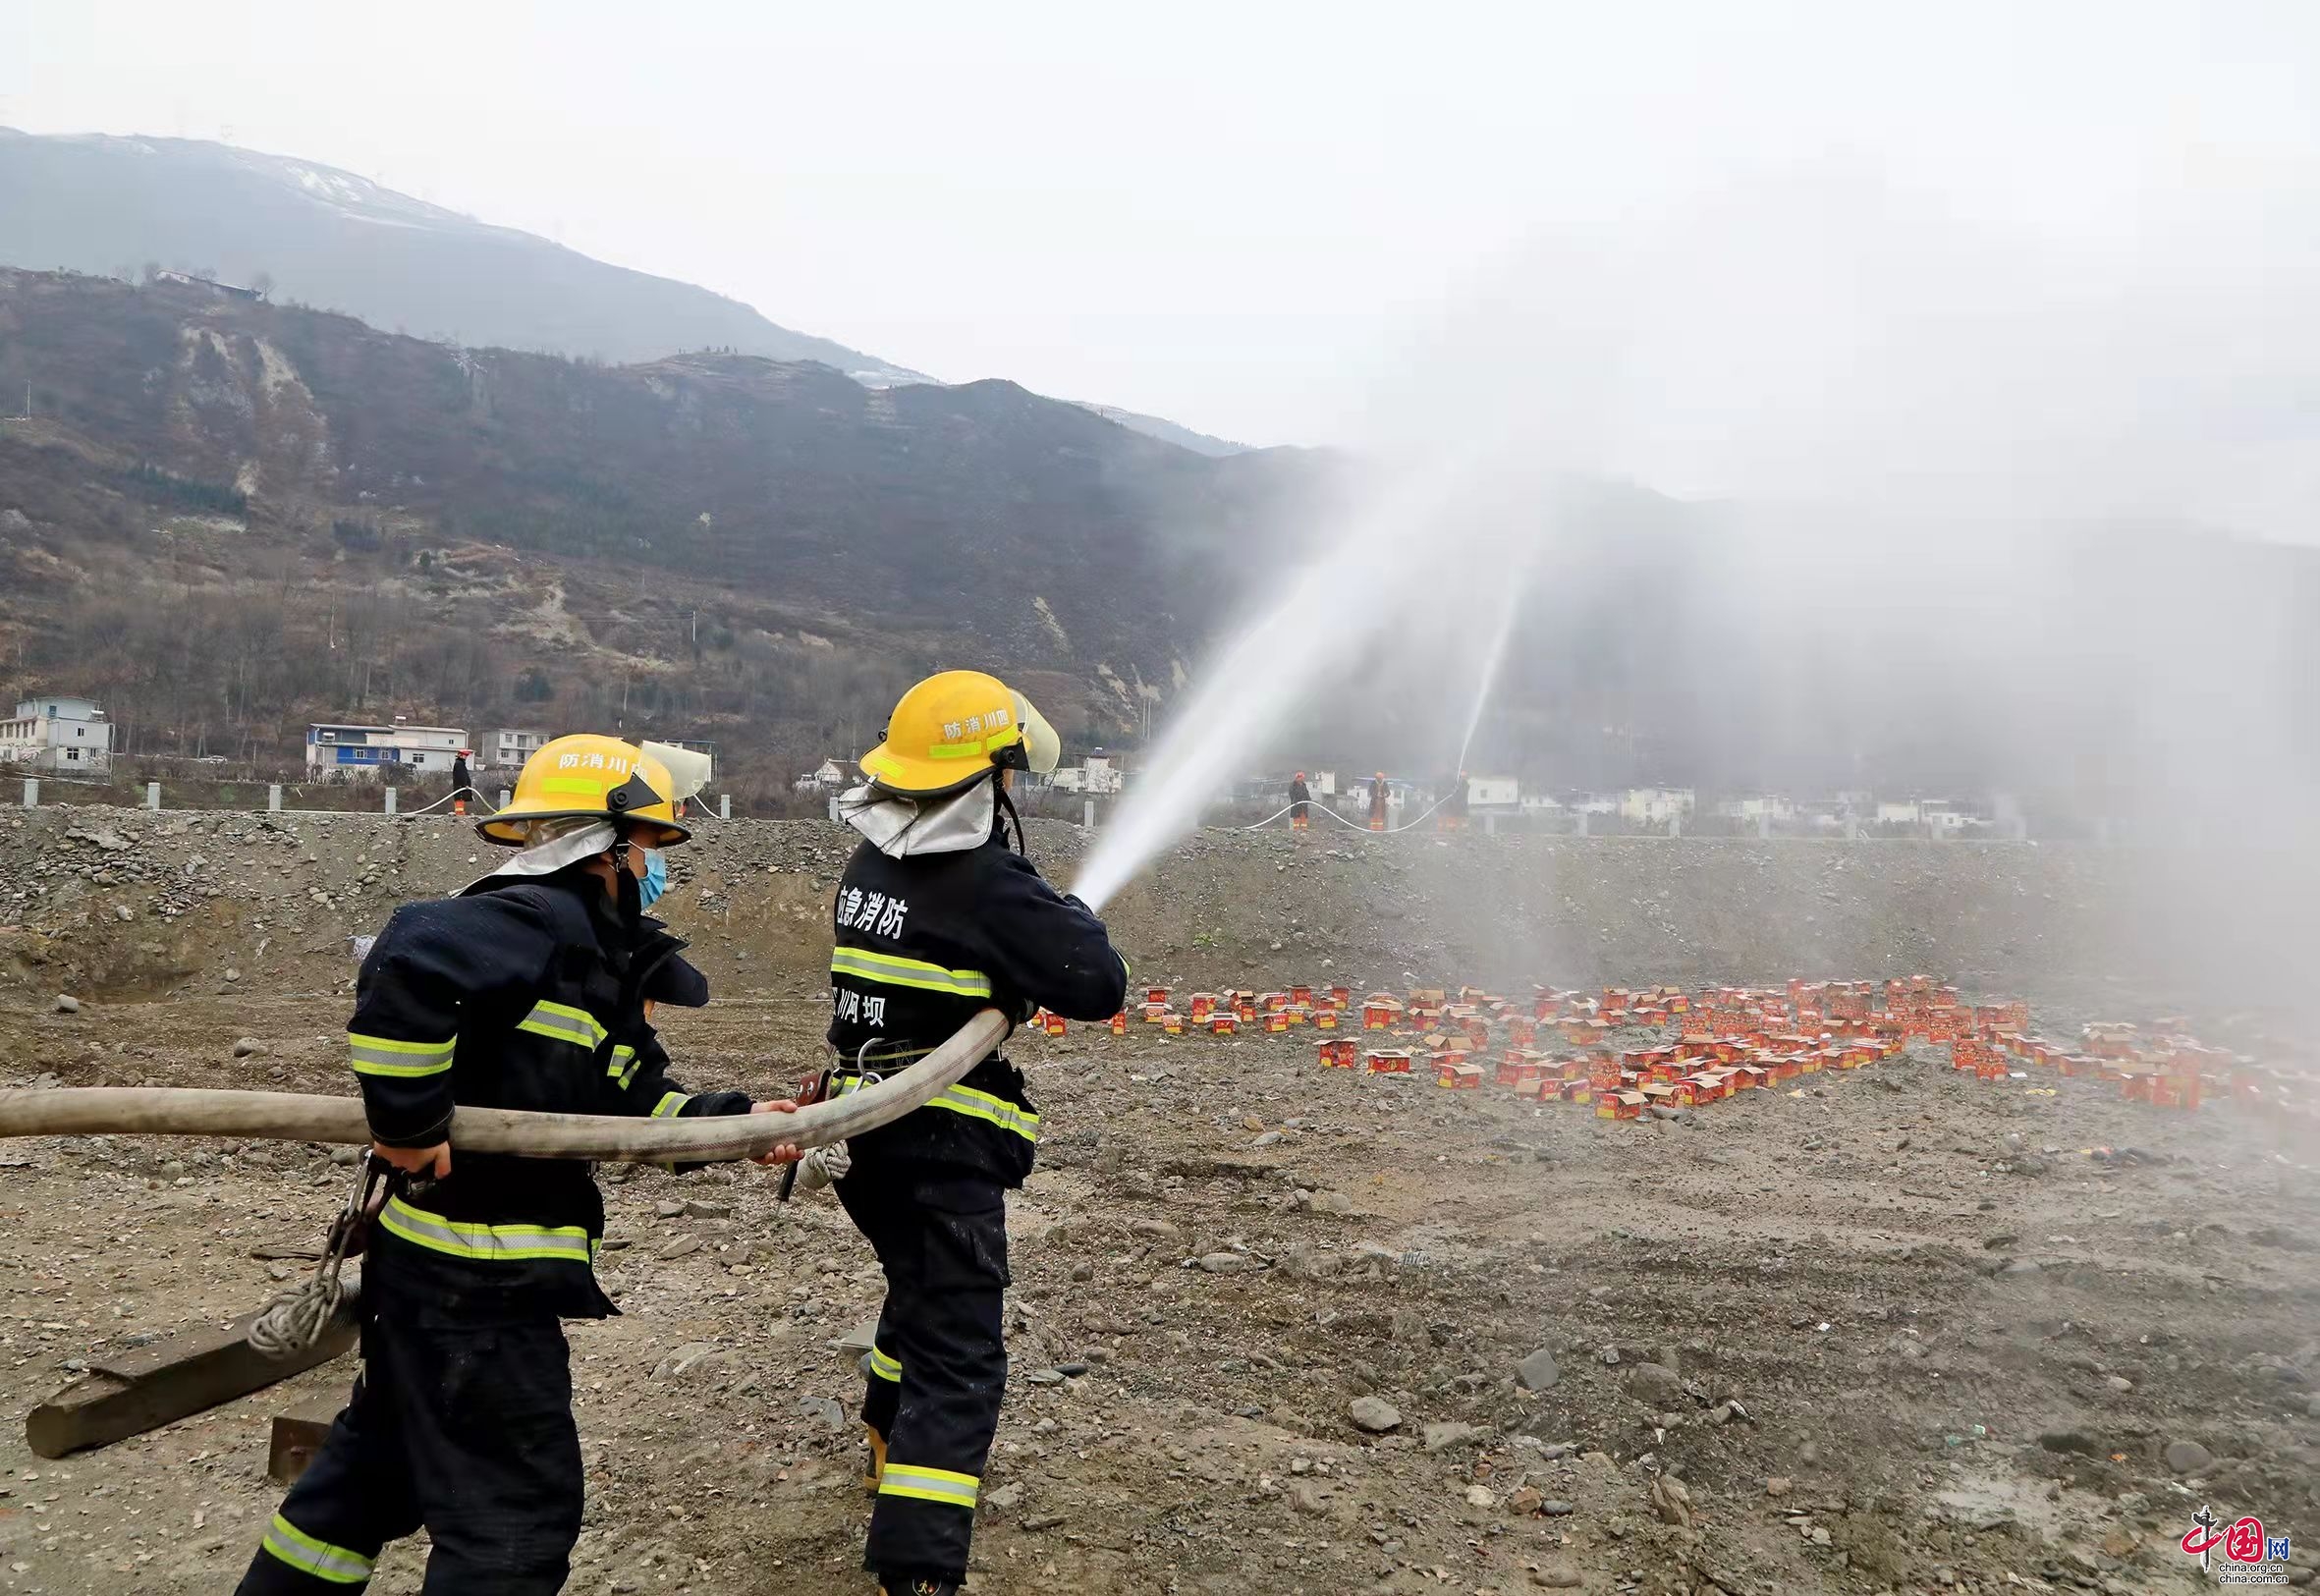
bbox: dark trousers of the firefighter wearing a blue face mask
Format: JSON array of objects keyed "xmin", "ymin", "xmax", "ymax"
[{"xmin": 239, "ymin": 1315, "xmax": 582, "ymax": 1596}]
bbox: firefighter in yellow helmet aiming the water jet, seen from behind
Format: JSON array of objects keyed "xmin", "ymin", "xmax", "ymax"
[{"xmin": 828, "ymin": 671, "xmax": 1128, "ymax": 1596}]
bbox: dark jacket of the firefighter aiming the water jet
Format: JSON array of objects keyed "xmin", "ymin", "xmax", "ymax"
[{"xmin": 831, "ymin": 823, "xmax": 1128, "ymax": 1185}]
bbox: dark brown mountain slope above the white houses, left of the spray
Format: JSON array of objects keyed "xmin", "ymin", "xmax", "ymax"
[{"xmin": 0, "ymin": 269, "xmax": 1303, "ymax": 770}]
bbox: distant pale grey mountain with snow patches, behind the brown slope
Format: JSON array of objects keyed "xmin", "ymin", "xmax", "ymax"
[{"xmin": 0, "ymin": 128, "xmax": 923, "ymax": 383}]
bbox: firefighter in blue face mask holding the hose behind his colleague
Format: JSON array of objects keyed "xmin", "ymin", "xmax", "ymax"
[{"xmin": 242, "ymin": 736, "xmax": 796, "ymax": 1596}]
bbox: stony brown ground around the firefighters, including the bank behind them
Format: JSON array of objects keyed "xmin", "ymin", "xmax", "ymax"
[{"xmin": 0, "ymin": 812, "xmax": 2320, "ymax": 1596}]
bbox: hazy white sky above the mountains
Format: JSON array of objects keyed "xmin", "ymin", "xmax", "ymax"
[{"xmin": 0, "ymin": 0, "xmax": 2320, "ymax": 536}]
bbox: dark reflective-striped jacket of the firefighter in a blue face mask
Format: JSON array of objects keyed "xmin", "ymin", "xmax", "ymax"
[{"xmin": 346, "ymin": 872, "xmax": 749, "ymax": 1320}]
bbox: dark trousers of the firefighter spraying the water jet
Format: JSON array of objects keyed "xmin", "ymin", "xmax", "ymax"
[{"xmin": 838, "ymin": 1162, "xmax": 1009, "ymax": 1589}]
